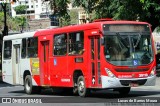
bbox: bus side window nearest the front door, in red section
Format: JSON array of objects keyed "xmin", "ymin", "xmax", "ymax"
[{"xmin": 68, "ymin": 32, "xmax": 84, "ymax": 55}]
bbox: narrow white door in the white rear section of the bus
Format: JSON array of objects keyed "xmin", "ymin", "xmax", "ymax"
[{"xmin": 12, "ymin": 44, "xmax": 20, "ymax": 84}]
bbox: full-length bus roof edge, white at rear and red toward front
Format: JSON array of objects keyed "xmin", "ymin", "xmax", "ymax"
[{"xmin": 3, "ymin": 21, "xmax": 148, "ymax": 40}]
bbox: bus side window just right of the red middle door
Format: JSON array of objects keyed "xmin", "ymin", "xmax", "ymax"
[{"xmin": 54, "ymin": 34, "xmax": 67, "ymax": 55}]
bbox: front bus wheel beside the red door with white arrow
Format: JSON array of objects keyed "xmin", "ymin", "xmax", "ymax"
[{"xmin": 77, "ymin": 76, "xmax": 89, "ymax": 97}]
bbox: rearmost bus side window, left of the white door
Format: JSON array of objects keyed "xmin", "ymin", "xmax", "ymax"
[{"xmin": 3, "ymin": 41, "xmax": 12, "ymax": 59}]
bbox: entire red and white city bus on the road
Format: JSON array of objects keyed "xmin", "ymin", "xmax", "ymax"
[{"xmin": 2, "ymin": 20, "xmax": 156, "ymax": 97}]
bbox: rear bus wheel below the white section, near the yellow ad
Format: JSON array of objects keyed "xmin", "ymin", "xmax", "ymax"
[{"xmin": 24, "ymin": 75, "xmax": 33, "ymax": 94}]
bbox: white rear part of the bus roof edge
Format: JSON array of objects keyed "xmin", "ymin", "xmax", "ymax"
[{"xmin": 3, "ymin": 32, "xmax": 35, "ymax": 40}]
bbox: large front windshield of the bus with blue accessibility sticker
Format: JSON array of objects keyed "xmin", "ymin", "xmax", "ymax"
[{"xmin": 104, "ymin": 32, "xmax": 153, "ymax": 66}]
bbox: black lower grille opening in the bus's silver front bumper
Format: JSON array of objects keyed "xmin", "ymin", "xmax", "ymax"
[{"xmin": 120, "ymin": 79, "xmax": 147, "ymax": 86}]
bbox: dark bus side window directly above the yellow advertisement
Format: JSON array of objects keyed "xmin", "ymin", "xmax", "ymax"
[{"xmin": 27, "ymin": 38, "xmax": 38, "ymax": 57}]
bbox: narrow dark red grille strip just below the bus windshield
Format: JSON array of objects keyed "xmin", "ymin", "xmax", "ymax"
[{"xmin": 115, "ymin": 68, "xmax": 149, "ymax": 72}]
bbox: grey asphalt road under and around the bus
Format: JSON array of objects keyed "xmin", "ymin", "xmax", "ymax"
[{"xmin": 0, "ymin": 77, "xmax": 160, "ymax": 106}]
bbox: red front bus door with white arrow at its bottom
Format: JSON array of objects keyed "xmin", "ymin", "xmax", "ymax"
[{"xmin": 89, "ymin": 36, "xmax": 101, "ymax": 87}]
